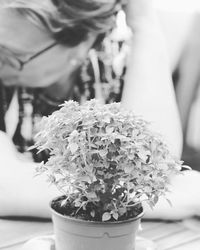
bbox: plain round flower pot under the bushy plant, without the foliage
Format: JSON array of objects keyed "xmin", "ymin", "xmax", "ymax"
[{"xmin": 51, "ymin": 199, "xmax": 143, "ymax": 250}]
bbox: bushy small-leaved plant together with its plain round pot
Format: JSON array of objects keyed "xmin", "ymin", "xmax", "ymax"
[{"xmin": 34, "ymin": 100, "xmax": 182, "ymax": 250}]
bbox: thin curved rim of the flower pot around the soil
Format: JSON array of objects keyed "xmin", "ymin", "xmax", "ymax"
[{"xmin": 49, "ymin": 196, "xmax": 144, "ymax": 226}]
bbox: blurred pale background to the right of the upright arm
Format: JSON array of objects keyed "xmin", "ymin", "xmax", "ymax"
[{"xmin": 154, "ymin": 0, "xmax": 200, "ymax": 170}]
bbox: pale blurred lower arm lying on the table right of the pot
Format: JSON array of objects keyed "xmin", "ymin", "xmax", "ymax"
[{"xmin": 145, "ymin": 170, "xmax": 200, "ymax": 220}]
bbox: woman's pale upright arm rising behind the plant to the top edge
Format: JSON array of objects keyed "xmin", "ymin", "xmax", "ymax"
[{"xmin": 122, "ymin": 0, "xmax": 182, "ymax": 157}]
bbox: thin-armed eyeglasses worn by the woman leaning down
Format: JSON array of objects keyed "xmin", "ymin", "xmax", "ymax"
[{"xmin": 0, "ymin": 42, "xmax": 57, "ymax": 71}]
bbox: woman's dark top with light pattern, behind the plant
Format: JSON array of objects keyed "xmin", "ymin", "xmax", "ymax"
[{"xmin": 0, "ymin": 33, "xmax": 128, "ymax": 161}]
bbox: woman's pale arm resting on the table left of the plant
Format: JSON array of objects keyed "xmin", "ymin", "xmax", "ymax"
[{"xmin": 0, "ymin": 131, "xmax": 59, "ymax": 218}]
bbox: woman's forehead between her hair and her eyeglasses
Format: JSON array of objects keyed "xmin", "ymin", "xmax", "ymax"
[{"xmin": 0, "ymin": 8, "xmax": 53, "ymax": 52}]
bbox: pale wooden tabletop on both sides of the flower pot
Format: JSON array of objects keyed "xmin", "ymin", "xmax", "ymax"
[{"xmin": 0, "ymin": 218, "xmax": 200, "ymax": 250}]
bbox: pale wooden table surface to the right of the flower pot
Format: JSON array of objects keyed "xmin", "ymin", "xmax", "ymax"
[{"xmin": 140, "ymin": 218, "xmax": 200, "ymax": 250}]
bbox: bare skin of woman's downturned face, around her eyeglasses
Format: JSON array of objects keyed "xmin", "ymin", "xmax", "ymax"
[{"xmin": 0, "ymin": 9, "xmax": 95, "ymax": 87}]
